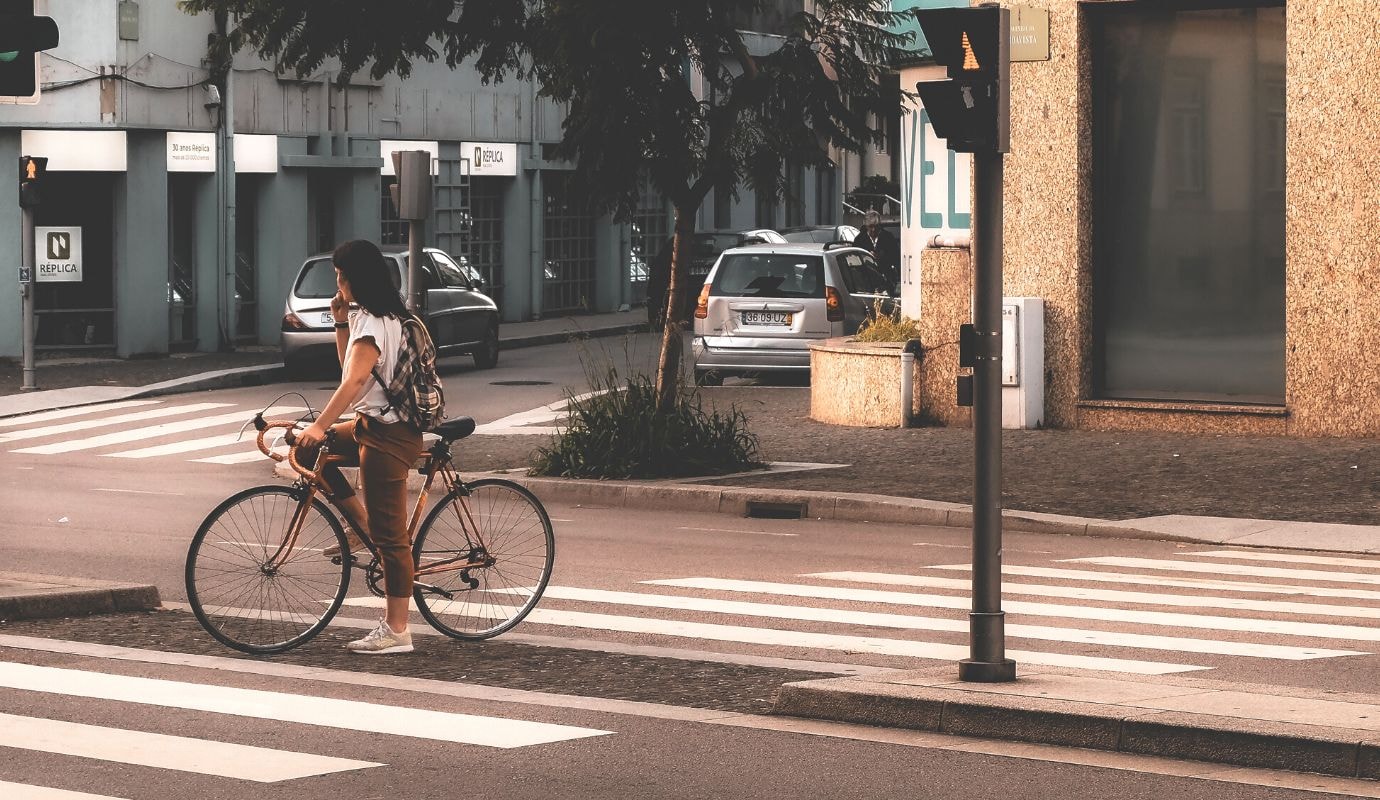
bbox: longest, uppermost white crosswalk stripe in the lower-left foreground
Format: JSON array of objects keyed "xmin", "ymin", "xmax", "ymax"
[{"xmin": 0, "ymin": 662, "xmax": 610, "ymax": 748}]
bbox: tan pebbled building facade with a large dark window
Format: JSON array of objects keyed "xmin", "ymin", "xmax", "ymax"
[{"xmin": 903, "ymin": 0, "xmax": 1380, "ymax": 436}]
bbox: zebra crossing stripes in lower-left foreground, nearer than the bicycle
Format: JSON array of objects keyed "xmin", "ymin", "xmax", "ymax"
[{"xmin": 0, "ymin": 637, "xmax": 611, "ymax": 800}]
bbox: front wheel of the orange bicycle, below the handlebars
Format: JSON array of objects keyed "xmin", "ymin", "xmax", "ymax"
[{"xmin": 185, "ymin": 486, "xmax": 349, "ymax": 654}]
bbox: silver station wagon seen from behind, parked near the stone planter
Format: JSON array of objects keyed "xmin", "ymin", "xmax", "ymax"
[{"xmin": 691, "ymin": 244, "xmax": 896, "ymax": 385}]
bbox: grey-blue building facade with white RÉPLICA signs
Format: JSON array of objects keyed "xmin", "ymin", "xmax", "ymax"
[{"xmin": 0, "ymin": 0, "xmax": 843, "ymax": 357}]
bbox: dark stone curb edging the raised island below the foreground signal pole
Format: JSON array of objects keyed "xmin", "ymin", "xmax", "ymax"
[{"xmin": 770, "ymin": 677, "xmax": 1380, "ymax": 779}]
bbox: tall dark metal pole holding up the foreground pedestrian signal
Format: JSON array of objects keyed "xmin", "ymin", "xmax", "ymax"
[{"xmin": 958, "ymin": 152, "xmax": 1016, "ymax": 683}]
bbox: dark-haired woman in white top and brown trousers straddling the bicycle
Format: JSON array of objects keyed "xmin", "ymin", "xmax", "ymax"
[{"xmin": 297, "ymin": 239, "xmax": 422, "ymax": 654}]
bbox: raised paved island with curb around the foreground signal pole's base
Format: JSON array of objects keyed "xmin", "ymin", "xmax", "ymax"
[{"xmin": 771, "ymin": 666, "xmax": 1380, "ymax": 779}]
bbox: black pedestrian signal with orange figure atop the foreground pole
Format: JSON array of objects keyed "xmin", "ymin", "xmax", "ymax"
[{"xmin": 915, "ymin": 4, "xmax": 1012, "ymax": 153}]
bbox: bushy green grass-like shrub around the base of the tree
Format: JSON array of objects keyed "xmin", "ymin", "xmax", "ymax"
[{"xmin": 527, "ymin": 367, "xmax": 763, "ymax": 479}]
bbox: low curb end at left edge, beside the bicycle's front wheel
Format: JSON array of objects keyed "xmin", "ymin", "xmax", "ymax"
[{"xmin": 0, "ymin": 572, "xmax": 161, "ymax": 621}]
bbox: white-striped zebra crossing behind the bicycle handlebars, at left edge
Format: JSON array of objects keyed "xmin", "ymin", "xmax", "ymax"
[{"xmin": 0, "ymin": 399, "xmax": 306, "ymax": 465}]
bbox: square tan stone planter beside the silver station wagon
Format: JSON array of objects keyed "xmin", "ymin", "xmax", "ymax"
[{"xmin": 810, "ymin": 338, "xmax": 922, "ymax": 428}]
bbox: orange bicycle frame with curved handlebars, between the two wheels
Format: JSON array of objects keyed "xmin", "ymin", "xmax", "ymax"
[{"xmin": 254, "ymin": 418, "xmax": 494, "ymax": 599}]
